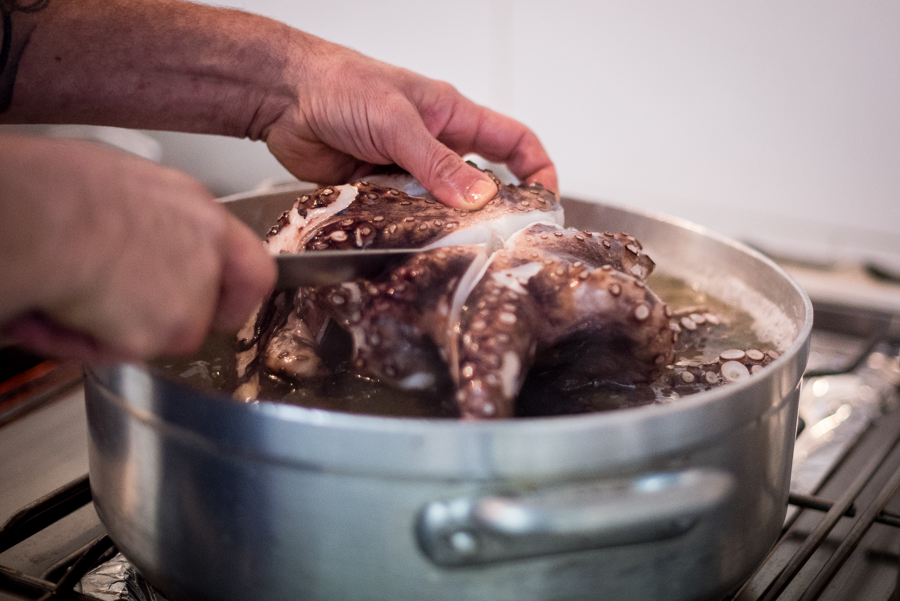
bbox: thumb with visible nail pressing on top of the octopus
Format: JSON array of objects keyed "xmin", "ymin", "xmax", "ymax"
[{"xmin": 392, "ymin": 121, "xmax": 497, "ymax": 211}]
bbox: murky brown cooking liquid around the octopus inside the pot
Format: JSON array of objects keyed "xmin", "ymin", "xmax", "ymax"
[{"xmin": 155, "ymin": 273, "xmax": 772, "ymax": 418}]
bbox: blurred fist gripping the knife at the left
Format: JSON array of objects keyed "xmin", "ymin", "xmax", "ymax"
[{"xmin": 0, "ymin": 136, "xmax": 275, "ymax": 361}]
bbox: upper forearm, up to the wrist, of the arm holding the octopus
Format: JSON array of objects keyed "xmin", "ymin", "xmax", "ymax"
[{"xmin": 0, "ymin": 0, "xmax": 302, "ymax": 139}]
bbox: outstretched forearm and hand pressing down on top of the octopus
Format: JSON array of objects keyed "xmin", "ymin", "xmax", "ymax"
[{"xmin": 0, "ymin": 0, "xmax": 557, "ymax": 209}]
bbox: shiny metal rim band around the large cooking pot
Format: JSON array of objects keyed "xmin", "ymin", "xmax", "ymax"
[{"xmin": 86, "ymin": 197, "xmax": 813, "ymax": 477}]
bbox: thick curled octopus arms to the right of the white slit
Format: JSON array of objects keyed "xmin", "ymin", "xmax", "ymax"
[{"xmin": 456, "ymin": 224, "xmax": 675, "ymax": 419}]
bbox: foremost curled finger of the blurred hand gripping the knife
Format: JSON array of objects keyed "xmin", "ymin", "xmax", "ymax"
[{"xmin": 212, "ymin": 215, "xmax": 275, "ymax": 332}]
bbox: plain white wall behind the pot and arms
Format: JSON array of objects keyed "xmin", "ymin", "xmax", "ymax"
[{"xmin": 156, "ymin": 0, "xmax": 900, "ymax": 265}]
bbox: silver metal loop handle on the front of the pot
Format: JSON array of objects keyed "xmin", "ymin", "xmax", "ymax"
[{"xmin": 416, "ymin": 468, "xmax": 735, "ymax": 567}]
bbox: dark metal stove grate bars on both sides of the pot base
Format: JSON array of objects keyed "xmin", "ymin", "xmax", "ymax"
[{"xmin": 0, "ymin": 316, "xmax": 900, "ymax": 601}]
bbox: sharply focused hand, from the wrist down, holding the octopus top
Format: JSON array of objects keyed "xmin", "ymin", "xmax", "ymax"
[{"xmin": 262, "ymin": 37, "xmax": 557, "ymax": 209}]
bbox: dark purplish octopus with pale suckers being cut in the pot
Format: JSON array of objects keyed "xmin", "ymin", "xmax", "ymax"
[{"xmin": 234, "ymin": 171, "xmax": 677, "ymax": 420}]
